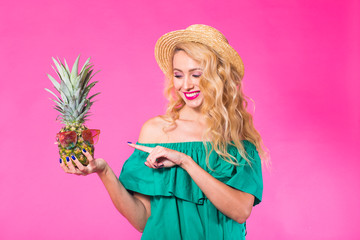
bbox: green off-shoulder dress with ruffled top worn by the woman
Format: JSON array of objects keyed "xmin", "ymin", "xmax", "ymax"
[{"xmin": 119, "ymin": 141, "xmax": 263, "ymax": 240}]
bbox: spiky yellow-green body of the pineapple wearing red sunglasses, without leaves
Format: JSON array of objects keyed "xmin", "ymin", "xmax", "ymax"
[{"xmin": 58, "ymin": 123, "xmax": 95, "ymax": 167}]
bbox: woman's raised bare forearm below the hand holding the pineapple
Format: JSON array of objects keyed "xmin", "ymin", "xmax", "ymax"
[{"xmin": 98, "ymin": 165, "xmax": 148, "ymax": 232}]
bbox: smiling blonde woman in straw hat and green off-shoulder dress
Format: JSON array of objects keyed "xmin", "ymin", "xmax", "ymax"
[{"xmin": 62, "ymin": 25, "xmax": 264, "ymax": 240}]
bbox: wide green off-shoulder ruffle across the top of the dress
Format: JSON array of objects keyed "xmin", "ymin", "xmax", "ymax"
[{"xmin": 119, "ymin": 141, "xmax": 262, "ymax": 205}]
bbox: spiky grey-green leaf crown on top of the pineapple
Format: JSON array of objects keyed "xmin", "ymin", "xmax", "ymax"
[{"xmin": 45, "ymin": 55, "xmax": 100, "ymax": 125}]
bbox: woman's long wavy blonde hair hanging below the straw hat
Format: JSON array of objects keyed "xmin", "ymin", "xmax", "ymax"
[{"xmin": 165, "ymin": 42, "xmax": 268, "ymax": 169}]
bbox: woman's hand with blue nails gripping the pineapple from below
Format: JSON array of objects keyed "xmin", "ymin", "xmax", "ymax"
[{"xmin": 60, "ymin": 150, "xmax": 107, "ymax": 176}]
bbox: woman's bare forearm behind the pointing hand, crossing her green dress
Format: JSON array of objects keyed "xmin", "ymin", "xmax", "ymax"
[{"xmin": 181, "ymin": 159, "xmax": 254, "ymax": 223}]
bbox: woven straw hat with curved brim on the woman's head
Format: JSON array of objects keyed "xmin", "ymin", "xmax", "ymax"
[{"xmin": 155, "ymin": 24, "xmax": 244, "ymax": 78}]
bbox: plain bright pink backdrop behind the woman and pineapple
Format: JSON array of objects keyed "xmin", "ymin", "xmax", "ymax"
[{"xmin": 0, "ymin": 0, "xmax": 360, "ymax": 240}]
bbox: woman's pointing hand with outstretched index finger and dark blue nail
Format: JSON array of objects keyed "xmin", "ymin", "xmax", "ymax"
[{"xmin": 128, "ymin": 143, "xmax": 192, "ymax": 168}]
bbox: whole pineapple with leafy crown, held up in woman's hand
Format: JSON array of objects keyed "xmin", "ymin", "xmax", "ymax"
[{"xmin": 45, "ymin": 55, "xmax": 100, "ymax": 166}]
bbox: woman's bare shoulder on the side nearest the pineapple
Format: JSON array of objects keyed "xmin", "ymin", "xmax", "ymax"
[{"xmin": 138, "ymin": 116, "xmax": 170, "ymax": 143}]
